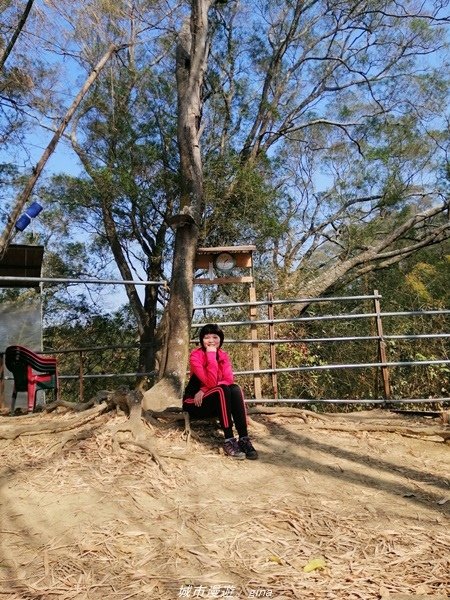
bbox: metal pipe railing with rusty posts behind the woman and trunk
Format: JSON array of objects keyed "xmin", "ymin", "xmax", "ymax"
[{"xmin": 0, "ymin": 292, "xmax": 450, "ymax": 404}]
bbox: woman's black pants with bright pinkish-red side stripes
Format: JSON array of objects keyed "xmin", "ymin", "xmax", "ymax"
[{"xmin": 183, "ymin": 383, "xmax": 248, "ymax": 438}]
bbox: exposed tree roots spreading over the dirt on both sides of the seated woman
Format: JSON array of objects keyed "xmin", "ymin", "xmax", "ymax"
[{"xmin": 0, "ymin": 388, "xmax": 450, "ymax": 466}]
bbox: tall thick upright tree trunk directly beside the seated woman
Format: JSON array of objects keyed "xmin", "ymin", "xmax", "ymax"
[{"xmin": 143, "ymin": 0, "xmax": 211, "ymax": 411}]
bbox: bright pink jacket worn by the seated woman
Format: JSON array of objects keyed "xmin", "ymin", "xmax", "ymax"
[{"xmin": 189, "ymin": 348, "xmax": 234, "ymax": 392}]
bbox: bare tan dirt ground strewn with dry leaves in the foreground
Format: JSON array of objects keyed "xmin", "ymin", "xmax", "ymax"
[{"xmin": 0, "ymin": 410, "xmax": 450, "ymax": 600}]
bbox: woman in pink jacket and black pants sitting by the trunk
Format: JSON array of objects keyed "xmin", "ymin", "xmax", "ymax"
[{"xmin": 183, "ymin": 323, "xmax": 258, "ymax": 460}]
